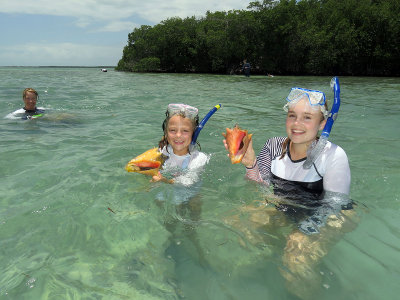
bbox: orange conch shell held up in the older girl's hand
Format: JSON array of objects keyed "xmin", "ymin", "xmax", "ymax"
[{"xmin": 222, "ymin": 125, "xmax": 253, "ymax": 164}]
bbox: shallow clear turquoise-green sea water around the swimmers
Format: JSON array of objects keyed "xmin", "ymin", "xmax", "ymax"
[{"xmin": 0, "ymin": 68, "xmax": 400, "ymax": 299}]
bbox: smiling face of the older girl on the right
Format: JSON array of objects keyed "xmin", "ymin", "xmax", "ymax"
[{"xmin": 286, "ymin": 98, "xmax": 326, "ymax": 147}]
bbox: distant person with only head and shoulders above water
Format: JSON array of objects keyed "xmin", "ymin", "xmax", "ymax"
[{"xmin": 6, "ymin": 88, "xmax": 44, "ymax": 120}]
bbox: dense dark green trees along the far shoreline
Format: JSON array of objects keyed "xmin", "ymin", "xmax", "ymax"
[{"xmin": 116, "ymin": 0, "xmax": 400, "ymax": 76}]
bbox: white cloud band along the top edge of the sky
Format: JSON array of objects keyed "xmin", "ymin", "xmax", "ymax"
[{"xmin": 0, "ymin": 0, "xmax": 250, "ymax": 31}]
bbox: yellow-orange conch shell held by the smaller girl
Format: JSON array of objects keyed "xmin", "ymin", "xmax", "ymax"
[{"xmin": 125, "ymin": 148, "xmax": 164, "ymax": 176}]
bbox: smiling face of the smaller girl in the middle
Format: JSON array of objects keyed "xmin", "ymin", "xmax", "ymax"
[{"xmin": 167, "ymin": 115, "xmax": 194, "ymax": 155}]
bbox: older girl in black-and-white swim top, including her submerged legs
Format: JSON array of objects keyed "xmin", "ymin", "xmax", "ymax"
[{"xmin": 223, "ymin": 88, "xmax": 354, "ymax": 298}]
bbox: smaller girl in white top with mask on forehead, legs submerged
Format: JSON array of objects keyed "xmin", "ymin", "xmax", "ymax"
[{"xmin": 152, "ymin": 104, "xmax": 209, "ymax": 272}]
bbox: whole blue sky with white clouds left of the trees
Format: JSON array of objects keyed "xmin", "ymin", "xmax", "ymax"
[{"xmin": 0, "ymin": 0, "xmax": 250, "ymax": 66}]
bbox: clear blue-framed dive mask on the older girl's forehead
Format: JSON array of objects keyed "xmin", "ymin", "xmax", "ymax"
[{"xmin": 283, "ymin": 87, "xmax": 328, "ymax": 119}]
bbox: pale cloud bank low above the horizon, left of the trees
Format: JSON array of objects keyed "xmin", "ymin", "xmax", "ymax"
[{"xmin": 0, "ymin": 43, "xmax": 123, "ymax": 66}]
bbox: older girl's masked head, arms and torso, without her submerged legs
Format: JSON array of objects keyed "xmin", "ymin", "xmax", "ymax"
[{"xmin": 224, "ymin": 88, "xmax": 351, "ymax": 234}]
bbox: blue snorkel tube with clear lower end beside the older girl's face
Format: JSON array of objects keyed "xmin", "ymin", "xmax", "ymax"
[{"xmin": 303, "ymin": 77, "xmax": 340, "ymax": 169}]
